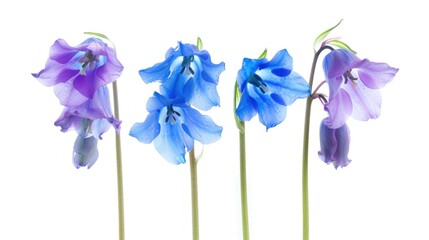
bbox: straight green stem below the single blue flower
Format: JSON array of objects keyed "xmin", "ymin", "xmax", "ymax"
[{"xmin": 239, "ymin": 122, "xmax": 249, "ymax": 240}]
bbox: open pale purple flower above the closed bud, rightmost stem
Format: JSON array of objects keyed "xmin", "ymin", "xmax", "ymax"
[{"xmin": 323, "ymin": 49, "xmax": 398, "ymax": 128}]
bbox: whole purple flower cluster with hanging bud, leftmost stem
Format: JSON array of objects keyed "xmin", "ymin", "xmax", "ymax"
[{"xmin": 32, "ymin": 38, "xmax": 123, "ymax": 168}]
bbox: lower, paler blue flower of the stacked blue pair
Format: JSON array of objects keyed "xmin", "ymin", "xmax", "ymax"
[{"xmin": 130, "ymin": 92, "xmax": 222, "ymax": 164}]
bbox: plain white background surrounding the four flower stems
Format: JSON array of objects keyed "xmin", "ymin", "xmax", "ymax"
[{"xmin": 0, "ymin": 0, "xmax": 429, "ymax": 240}]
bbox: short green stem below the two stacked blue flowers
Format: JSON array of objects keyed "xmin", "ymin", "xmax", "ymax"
[{"xmin": 189, "ymin": 147, "xmax": 200, "ymax": 240}]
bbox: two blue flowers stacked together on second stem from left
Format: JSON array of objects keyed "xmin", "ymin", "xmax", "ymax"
[{"xmin": 130, "ymin": 42, "xmax": 225, "ymax": 164}]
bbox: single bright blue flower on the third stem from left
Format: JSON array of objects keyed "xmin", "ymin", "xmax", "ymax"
[{"xmin": 236, "ymin": 49, "xmax": 310, "ymax": 130}]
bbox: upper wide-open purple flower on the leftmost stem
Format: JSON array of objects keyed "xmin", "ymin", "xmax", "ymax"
[{"xmin": 32, "ymin": 38, "xmax": 123, "ymax": 107}]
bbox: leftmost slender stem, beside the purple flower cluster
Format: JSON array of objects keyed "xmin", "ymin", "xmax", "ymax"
[{"xmin": 112, "ymin": 81, "xmax": 125, "ymax": 240}]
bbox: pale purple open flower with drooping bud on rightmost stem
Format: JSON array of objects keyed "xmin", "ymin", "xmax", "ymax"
[{"xmin": 319, "ymin": 46, "xmax": 398, "ymax": 168}]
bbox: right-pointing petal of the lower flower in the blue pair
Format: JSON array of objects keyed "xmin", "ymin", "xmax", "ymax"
[{"xmin": 181, "ymin": 108, "xmax": 222, "ymax": 144}]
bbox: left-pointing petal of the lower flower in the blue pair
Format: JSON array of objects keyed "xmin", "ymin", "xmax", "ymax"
[{"xmin": 130, "ymin": 111, "xmax": 160, "ymax": 144}]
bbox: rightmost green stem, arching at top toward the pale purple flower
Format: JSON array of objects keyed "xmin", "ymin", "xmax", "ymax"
[{"xmin": 302, "ymin": 46, "xmax": 329, "ymax": 240}]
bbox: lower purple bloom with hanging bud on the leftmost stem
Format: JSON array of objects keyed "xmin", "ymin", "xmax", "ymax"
[{"xmin": 55, "ymin": 86, "xmax": 121, "ymax": 168}]
